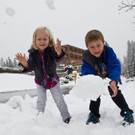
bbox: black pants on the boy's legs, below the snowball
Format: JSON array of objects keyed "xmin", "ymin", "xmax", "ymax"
[{"xmin": 89, "ymin": 86, "xmax": 133, "ymax": 118}]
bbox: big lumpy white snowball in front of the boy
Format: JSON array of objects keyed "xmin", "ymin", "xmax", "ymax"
[{"xmin": 71, "ymin": 75, "xmax": 106, "ymax": 100}]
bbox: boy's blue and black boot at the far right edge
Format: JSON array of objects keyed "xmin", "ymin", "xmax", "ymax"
[{"xmin": 122, "ymin": 111, "xmax": 134, "ymax": 126}]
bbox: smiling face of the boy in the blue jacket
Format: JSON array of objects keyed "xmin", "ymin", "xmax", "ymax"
[{"xmin": 88, "ymin": 40, "xmax": 104, "ymax": 57}]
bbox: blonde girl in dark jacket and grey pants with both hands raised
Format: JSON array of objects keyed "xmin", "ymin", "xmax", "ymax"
[{"xmin": 15, "ymin": 27, "xmax": 71, "ymax": 123}]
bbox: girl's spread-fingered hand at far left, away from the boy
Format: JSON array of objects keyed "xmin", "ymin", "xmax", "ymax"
[{"xmin": 15, "ymin": 53, "xmax": 28, "ymax": 68}]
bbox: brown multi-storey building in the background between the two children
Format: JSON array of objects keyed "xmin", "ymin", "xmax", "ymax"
[{"xmin": 60, "ymin": 45, "xmax": 85, "ymax": 65}]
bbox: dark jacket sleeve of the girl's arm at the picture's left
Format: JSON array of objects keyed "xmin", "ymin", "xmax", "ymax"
[{"xmin": 22, "ymin": 54, "xmax": 35, "ymax": 73}]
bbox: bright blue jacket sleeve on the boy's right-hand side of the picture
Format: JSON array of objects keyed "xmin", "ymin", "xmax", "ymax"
[{"xmin": 106, "ymin": 47, "xmax": 121, "ymax": 83}]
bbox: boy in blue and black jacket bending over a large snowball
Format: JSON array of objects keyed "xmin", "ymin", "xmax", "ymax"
[{"xmin": 81, "ymin": 30, "xmax": 134, "ymax": 125}]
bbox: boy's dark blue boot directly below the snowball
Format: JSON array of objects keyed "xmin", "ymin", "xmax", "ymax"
[{"xmin": 86, "ymin": 112, "xmax": 99, "ymax": 125}]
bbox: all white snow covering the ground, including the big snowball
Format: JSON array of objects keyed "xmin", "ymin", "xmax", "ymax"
[{"xmin": 0, "ymin": 74, "xmax": 135, "ymax": 135}]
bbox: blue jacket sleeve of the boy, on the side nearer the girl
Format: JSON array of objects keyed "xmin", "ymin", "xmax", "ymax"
[{"xmin": 81, "ymin": 60, "xmax": 95, "ymax": 76}]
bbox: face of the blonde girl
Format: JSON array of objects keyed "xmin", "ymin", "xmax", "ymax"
[{"xmin": 36, "ymin": 30, "xmax": 49, "ymax": 52}]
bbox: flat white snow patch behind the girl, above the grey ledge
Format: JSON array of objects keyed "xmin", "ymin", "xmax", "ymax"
[{"xmin": 0, "ymin": 73, "xmax": 36, "ymax": 92}]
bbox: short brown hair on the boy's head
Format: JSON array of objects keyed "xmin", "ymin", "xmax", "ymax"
[{"xmin": 85, "ymin": 30, "xmax": 104, "ymax": 47}]
